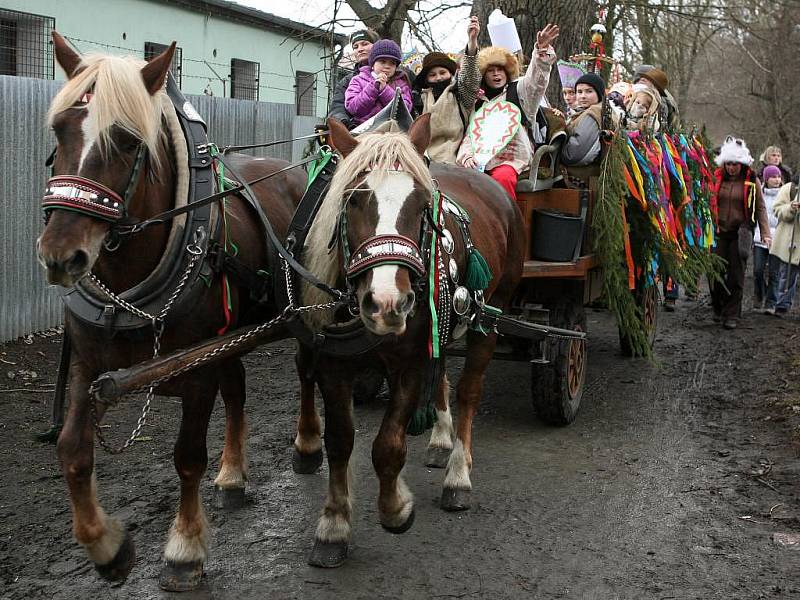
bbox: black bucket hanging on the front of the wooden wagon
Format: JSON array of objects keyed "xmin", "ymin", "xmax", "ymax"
[{"xmin": 531, "ymin": 208, "xmax": 585, "ymax": 262}]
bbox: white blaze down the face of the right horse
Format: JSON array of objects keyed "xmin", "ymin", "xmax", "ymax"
[{"xmin": 366, "ymin": 171, "xmax": 414, "ymax": 310}]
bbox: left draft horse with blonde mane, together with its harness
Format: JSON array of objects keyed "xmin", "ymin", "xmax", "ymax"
[{"xmin": 37, "ymin": 32, "xmax": 305, "ymax": 591}]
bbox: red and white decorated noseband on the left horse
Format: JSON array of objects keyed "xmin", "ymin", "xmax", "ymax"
[{"xmin": 42, "ymin": 175, "xmax": 126, "ymax": 221}]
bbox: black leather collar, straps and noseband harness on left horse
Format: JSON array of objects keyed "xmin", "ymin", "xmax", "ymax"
[{"xmin": 42, "ymin": 76, "xmax": 324, "ymax": 337}]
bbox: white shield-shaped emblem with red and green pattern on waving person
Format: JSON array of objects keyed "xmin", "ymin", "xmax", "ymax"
[{"xmin": 469, "ymin": 98, "xmax": 522, "ymax": 171}]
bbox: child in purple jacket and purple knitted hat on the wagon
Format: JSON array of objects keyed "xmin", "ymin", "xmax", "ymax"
[{"xmin": 344, "ymin": 40, "xmax": 411, "ymax": 125}]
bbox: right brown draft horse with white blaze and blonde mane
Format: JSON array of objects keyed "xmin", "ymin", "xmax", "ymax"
[{"xmin": 295, "ymin": 115, "xmax": 525, "ymax": 567}]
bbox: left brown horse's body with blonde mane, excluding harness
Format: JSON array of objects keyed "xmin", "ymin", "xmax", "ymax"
[{"xmin": 38, "ymin": 33, "xmax": 305, "ymax": 590}]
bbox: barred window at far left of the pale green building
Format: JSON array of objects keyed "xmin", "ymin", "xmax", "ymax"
[{"xmin": 0, "ymin": 9, "xmax": 56, "ymax": 79}]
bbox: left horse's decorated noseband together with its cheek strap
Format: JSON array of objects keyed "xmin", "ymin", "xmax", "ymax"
[{"xmin": 42, "ymin": 144, "xmax": 147, "ymax": 223}]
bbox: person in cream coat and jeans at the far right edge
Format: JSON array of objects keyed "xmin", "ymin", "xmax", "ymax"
[{"xmin": 764, "ymin": 183, "xmax": 800, "ymax": 316}]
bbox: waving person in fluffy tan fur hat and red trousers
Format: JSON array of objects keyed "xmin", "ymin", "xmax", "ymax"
[{"xmin": 456, "ymin": 25, "xmax": 558, "ymax": 200}]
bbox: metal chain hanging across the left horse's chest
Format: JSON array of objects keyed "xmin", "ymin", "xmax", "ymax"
[{"xmin": 87, "ymin": 231, "xmax": 205, "ymax": 454}]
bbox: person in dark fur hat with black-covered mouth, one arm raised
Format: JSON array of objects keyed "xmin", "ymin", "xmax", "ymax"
[{"xmin": 414, "ymin": 17, "xmax": 481, "ymax": 164}]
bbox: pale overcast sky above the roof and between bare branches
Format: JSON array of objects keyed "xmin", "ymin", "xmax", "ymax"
[{"xmin": 234, "ymin": 0, "xmax": 476, "ymax": 52}]
